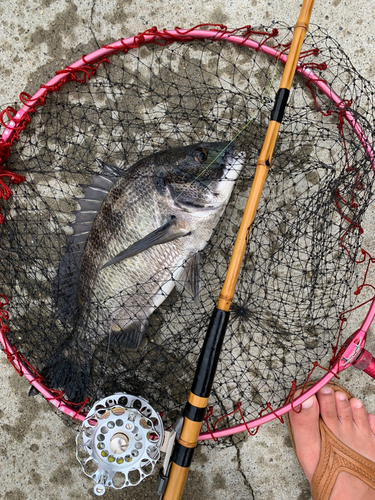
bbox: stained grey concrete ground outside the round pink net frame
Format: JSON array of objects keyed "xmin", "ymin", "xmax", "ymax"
[{"xmin": 0, "ymin": 0, "xmax": 375, "ymax": 500}]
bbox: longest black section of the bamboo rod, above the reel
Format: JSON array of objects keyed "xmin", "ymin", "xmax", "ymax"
[{"xmin": 191, "ymin": 307, "xmax": 229, "ymax": 398}]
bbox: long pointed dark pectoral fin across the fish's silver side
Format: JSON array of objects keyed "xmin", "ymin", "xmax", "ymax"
[{"xmin": 101, "ymin": 216, "xmax": 190, "ymax": 270}]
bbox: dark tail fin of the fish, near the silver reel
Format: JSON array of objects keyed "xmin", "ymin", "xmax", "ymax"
[{"xmin": 29, "ymin": 342, "xmax": 90, "ymax": 403}]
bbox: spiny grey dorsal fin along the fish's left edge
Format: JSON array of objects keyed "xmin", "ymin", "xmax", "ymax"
[{"xmin": 53, "ymin": 160, "xmax": 121, "ymax": 319}]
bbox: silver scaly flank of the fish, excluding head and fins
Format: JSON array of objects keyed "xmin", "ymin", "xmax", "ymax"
[{"xmin": 79, "ymin": 158, "xmax": 232, "ymax": 341}]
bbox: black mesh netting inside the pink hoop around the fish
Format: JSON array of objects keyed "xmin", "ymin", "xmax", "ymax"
[{"xmin": 0, "ymin": 26, "xmax": 374, "ymax": 442}]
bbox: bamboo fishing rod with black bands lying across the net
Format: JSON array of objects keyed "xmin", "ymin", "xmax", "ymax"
[{"xmin": 160, "ymin": 0, "xmax": 314, "ymax": 500}]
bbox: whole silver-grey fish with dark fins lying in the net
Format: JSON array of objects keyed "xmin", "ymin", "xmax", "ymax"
[{"xmin": 31, "ymin": 142, "xmax": 245, "ymax": 403}]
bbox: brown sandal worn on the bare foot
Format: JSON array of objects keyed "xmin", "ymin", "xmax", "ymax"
[{"xmin": 286, "ymin": 381, "xmax": 375, "ymax": 500}]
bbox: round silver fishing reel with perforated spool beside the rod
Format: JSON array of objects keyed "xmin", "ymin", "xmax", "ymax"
[{"xmin": 76, "ymin": 393, "xmax": 164, "ymax": 496}]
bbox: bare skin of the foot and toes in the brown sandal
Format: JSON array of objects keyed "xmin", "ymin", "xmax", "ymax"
[{"xmin": 289, "ymin": 386, "xmax": 375, "ymax": 500}]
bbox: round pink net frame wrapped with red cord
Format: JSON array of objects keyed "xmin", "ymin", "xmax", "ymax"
[{"xmin": 0, "ymin": 24, "xmax": 375, "ymax": 441}]
